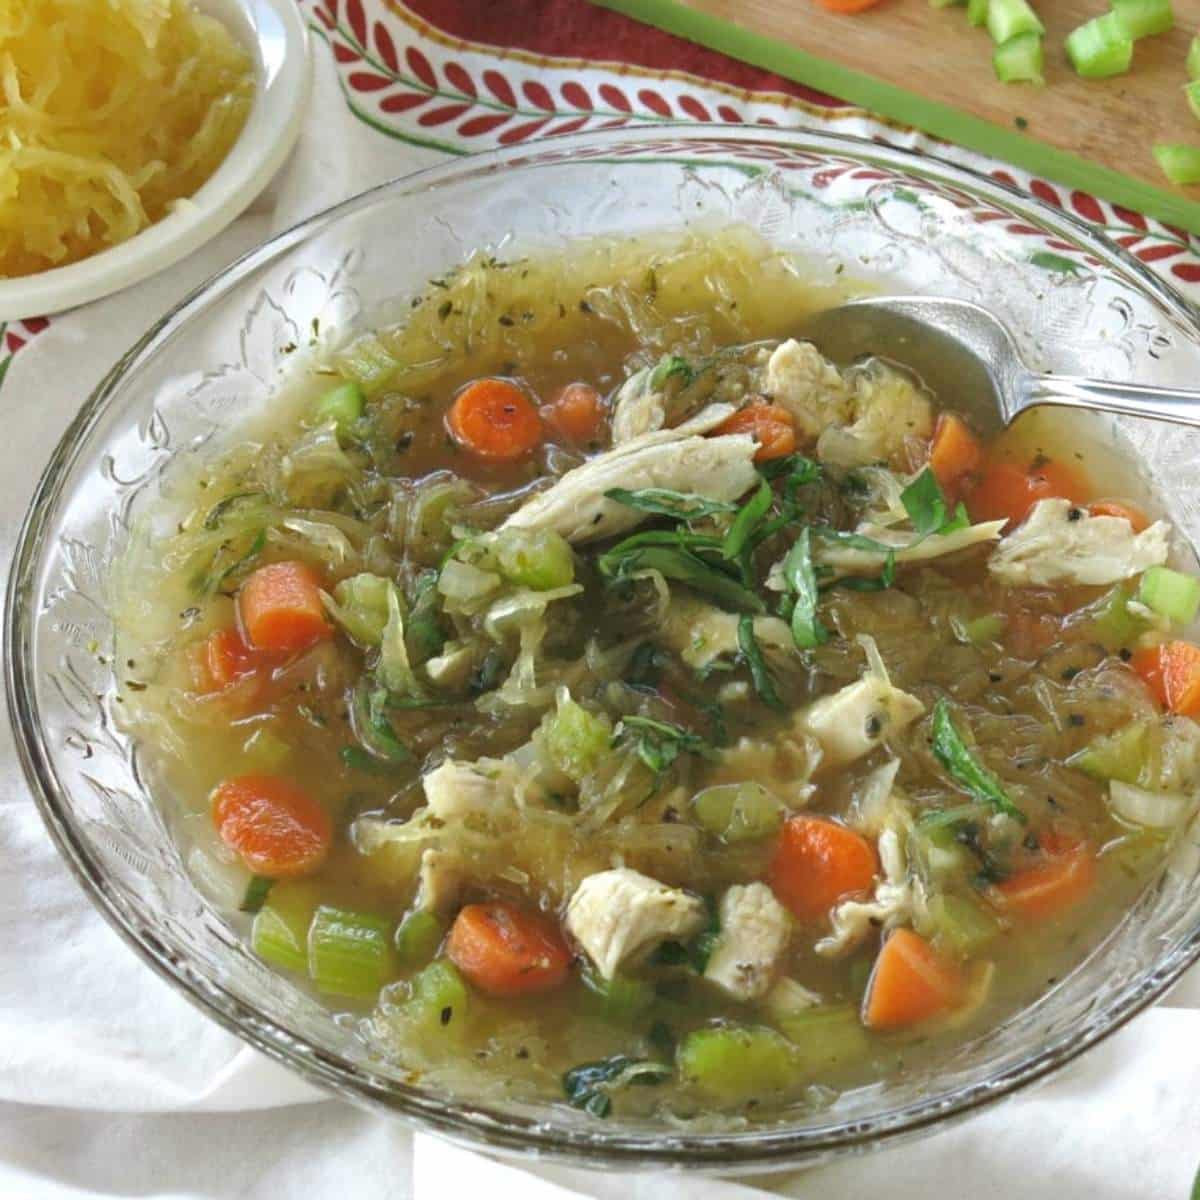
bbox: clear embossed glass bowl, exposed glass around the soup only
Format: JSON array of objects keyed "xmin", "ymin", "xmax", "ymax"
[{"xmin": 5, "ymin": 127, "xmax": 1200, "ymax": 1174}]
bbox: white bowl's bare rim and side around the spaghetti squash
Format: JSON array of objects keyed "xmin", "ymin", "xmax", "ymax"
[{"xmin": 0, "ymin": 0, "xmax": 308, "ymax": 320}]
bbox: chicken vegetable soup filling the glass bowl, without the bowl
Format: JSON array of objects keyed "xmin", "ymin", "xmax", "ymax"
[{"xmin": 115, "ymin": 230, "xmax": 1200, "ymax": 1120}]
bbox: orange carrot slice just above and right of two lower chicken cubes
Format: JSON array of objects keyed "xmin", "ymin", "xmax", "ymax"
[{"xmin": 767, "ymin": 815, "xmax": 880, "ymax": 920}]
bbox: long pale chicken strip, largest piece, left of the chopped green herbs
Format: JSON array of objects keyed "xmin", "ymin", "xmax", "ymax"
[{"xmin": 503, "ymin": 404, "xmax": 758, "ymax": 542}]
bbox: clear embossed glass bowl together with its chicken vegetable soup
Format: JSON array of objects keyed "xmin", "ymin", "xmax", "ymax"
[{"xmin": 10, "ymin": 131, "xmax": 1198, "ymax": 1170}]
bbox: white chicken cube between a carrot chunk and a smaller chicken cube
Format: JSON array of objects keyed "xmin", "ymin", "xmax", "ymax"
[{"xmin": 566, "ymin": 868, "xmax": 708, "ymax": 979}]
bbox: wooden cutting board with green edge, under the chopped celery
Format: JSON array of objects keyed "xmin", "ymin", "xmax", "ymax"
[{"xmin": 599, "ymin": 0, "xmax": 1200, "ymax": 233}]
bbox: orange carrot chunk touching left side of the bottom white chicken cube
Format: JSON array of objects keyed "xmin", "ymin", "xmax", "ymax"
[{"xmin": 446, "ymin": 900, "xmax": 571, "ymax": 996}]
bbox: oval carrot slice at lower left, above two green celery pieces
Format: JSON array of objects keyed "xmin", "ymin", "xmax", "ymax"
[{"xmin": 212, "ymin": 774, "xmax": 334, "ymax": 878}]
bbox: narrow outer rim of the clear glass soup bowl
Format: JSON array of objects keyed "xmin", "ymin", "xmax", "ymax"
[{"xmin": 4, "ymin": 125, "xmax": 1200, "ymax": 1171}]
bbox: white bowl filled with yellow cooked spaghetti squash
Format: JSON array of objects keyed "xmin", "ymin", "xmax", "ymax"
[{"xmin": 0, "ymin": 0, "xmax": 308, "ymax": 320}]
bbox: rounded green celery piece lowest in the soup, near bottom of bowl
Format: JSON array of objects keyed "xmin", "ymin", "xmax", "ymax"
[{"xmin": 676, "ymin": 1025, "xmax": 798, "ymax": 1104}]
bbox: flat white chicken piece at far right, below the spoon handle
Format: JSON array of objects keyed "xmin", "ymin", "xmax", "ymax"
[{"xmin": 988, "ymin": 500, "xmax": 1170, "ymax": 587}]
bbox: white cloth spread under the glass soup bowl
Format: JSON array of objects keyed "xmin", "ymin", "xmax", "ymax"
[{"xmin": 7, "ymin": 9, "xmax": 1200, "ymax": 1200}]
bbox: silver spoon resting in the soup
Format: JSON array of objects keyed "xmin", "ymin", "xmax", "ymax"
[{"xmin": 799, "ymin": 296, "xmax": 1200, "ymax": 433}]
